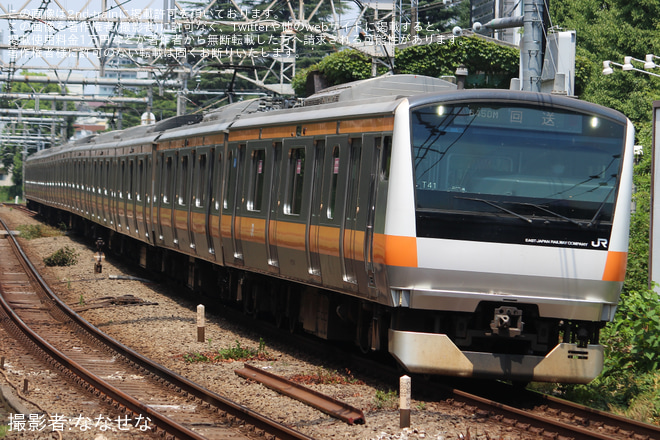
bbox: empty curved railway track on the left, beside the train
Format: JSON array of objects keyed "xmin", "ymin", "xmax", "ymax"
[{"xmin": 0, "ymin": 220, "xmax": 310, "ymax": 440}]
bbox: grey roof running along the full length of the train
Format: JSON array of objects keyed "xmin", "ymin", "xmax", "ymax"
[{"xmin": 25, "ymin": 75, "xmax": 627, "ymax": 163}]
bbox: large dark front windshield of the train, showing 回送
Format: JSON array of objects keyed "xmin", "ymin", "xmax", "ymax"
[{"xmin": 411, "ymin": 103, "xmax": 625, "ymax": 243}]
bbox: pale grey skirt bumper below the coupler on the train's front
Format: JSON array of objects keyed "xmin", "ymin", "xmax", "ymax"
[{"xmin": 389, "ymin": 329, "xmax": 604, "ymax": 383}]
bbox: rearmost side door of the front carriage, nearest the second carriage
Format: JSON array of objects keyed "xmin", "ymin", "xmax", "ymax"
[{"xmin": 221, "ymin": 142, "xmax": 245, "ymax": 265}]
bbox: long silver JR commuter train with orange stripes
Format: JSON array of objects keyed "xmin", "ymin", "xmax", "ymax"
[{"xmin": 24, "ymin": 75, "xmax": 634, "ymax": 383}]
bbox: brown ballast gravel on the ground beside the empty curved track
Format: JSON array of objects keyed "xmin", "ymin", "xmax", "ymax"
[{"xmin": 0, "ymin": 206, "xmax": 533, "ymax": 440}]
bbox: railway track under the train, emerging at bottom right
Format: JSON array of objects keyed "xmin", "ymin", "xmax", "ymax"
[{"xmin": 0, "ymin": 206, "xmax": 660, "ymax": 440}]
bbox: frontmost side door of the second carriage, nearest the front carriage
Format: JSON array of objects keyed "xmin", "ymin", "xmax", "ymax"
[{"xmin": 190, "ymin": 146, "xmax": 214, "ymax": 259}]
